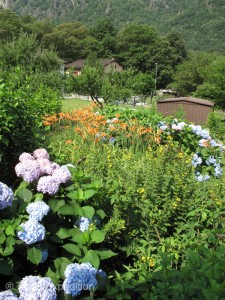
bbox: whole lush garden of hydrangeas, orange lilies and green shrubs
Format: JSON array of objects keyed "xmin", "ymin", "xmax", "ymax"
[{"xmin": 0, "ymin": 84, "xmax": 225, "ymax": 300}]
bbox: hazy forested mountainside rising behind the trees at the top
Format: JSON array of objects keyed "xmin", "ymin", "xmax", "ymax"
[{"xmin": 0, "ymin": 0, "xmax": 225, "ymax": 53}]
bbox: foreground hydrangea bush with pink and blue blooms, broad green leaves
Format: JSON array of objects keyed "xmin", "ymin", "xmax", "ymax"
[{"xmin": 0, "ymin": 149, "xmax": 111, "ymax": 300}]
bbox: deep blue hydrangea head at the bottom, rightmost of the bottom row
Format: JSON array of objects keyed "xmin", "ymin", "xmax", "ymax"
[{"xmin": 63, "ymin": 263, "xmax": 98, "ymax": 297}]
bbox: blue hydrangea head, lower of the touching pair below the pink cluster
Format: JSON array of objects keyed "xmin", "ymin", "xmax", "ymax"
[{"xmin": 17, "ymin": 219, "xmax": 45, "ymax": 245}]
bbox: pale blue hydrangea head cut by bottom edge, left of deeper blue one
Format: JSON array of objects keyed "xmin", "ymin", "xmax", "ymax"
[{"xmin": 18, "ymin": 276, "xmax": 57, "ymax": 300}]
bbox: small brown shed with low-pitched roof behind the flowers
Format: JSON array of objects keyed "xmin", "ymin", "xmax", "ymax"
[{"xmin": 157, "ymin": 97, "xmax": 214, "ymax": 124}]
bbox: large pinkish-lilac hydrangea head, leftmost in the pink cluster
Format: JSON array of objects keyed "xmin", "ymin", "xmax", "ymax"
[{"xmin": 15, "ymin": 159, "xmax": 41, "ymax": 183}]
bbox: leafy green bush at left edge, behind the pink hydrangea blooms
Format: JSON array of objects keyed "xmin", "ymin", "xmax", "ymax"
[{"xmin": 0, "ymin": 68, "xmax": 61, "ymax": 182}]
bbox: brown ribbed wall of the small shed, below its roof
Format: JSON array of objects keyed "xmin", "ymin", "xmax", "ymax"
[{"xmin": 157, "ymin": 101, "xmax": 213, "ymax": 124}]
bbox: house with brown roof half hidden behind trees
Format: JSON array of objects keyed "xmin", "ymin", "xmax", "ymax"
[{"xmin": 65, "ymin": 58, "xmax": 123, "ymax": 75}]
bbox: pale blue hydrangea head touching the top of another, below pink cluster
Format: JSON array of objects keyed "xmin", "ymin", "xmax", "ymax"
[{"xmin": 26, "ymin": 201, "xmax": 50, "ymax": 221}]
